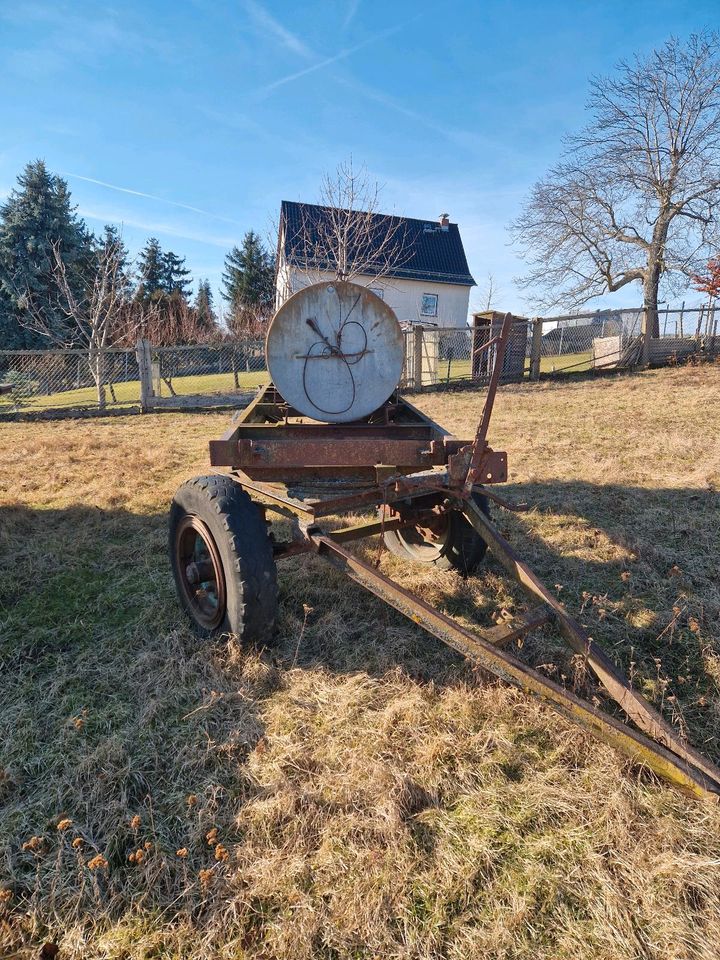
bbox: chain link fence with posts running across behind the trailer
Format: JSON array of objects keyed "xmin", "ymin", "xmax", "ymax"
[{"xmin": 0, "ymin": 305, "xmax": 720, "ymax": 416}]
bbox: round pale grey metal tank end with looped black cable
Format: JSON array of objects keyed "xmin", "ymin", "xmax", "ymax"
[{"xmin": 265, "ymin": 281, "xmax": 405, "ymax": 423}]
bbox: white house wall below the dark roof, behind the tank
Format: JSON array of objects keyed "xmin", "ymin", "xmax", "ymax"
[{"xmin": 276, "ymin": 262, "xmax": 471, "ymax": 327}]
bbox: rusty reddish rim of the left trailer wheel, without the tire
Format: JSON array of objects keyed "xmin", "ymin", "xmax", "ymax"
[{"xmin": 175, "ymin": 516, "xmax": 226, "ymax": 630}]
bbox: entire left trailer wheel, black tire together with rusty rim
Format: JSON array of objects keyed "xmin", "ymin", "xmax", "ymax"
[{"xmin": 169, "ymin": 474, "xmax": 277, "ymax": 643}]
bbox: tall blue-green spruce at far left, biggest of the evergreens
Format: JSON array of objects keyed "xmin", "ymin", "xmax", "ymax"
[{"xmin": 0, "ymin": 160, "xmax": 92, "ymax": 349}]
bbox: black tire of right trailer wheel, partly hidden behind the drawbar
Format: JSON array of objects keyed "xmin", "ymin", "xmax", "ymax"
[{"xmin": 383, "ymin": 493, "xmax": 490, "ymax": 575}]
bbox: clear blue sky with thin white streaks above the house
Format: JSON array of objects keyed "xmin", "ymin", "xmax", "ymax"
[{"xmin": 0, "ymin": 0, "xmax": 720, "ymax": 310}]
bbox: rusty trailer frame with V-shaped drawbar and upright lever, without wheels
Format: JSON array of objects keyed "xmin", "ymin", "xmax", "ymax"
[{"xmin": 201, "ymin": 314, "xmax": 720, "ymax": 801}]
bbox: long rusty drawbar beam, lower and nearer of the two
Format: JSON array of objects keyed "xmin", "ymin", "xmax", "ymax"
[{"xmin": 308, "ymin": 530, "xmax": 720, "ymax": 802}]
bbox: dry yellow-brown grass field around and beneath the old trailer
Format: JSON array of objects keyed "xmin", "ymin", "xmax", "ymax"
[{"xmin": 0, "ymin": 366, "xmax": 720, "ymax": 960}]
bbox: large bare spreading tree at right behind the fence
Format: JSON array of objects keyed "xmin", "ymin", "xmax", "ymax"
[{"xmin": 513, "ymin": 34, "xmax": 720, "ymax": 336}]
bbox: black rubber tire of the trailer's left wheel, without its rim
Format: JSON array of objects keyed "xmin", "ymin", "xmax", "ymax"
[{"xmin": 169, "ymin": 474, "xmax": 278, "ymax": 643}]
